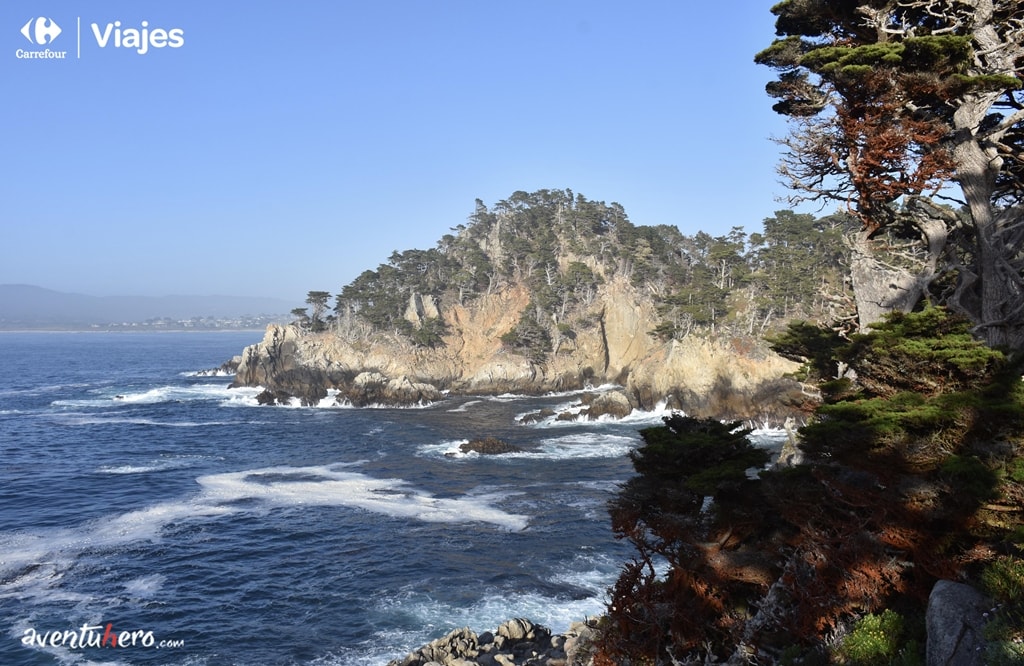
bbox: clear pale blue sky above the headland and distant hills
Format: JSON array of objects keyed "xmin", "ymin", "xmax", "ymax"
[{"xmin": 0, "ymin": 0, "xmax": 786, "ymax": 305}]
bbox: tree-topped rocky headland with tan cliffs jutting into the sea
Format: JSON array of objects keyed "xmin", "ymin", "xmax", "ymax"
[{"xmin": 224, "ymin": 190, "xmax": 820, "ymax": 424}]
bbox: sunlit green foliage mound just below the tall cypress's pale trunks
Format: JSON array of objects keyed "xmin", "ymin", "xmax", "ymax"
[{"xmin": 802, "ymin": 307, "xmax": 1024, "ymax": 467}]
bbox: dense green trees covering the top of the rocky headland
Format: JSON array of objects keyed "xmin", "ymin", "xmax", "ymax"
[{"xmin": 298, "ymin": 190, "xmax": 854, "ymax": 355}]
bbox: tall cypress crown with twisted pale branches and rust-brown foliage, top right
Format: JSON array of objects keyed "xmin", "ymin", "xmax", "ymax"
[{"xmin": 755, "ymin": 0, "xmax": 1024, "ymax": 348}]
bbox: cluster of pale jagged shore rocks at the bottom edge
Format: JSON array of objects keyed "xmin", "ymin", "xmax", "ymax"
[{"xmin": 388, "ymin": 618, "xmax": 598, "ymax": 666}]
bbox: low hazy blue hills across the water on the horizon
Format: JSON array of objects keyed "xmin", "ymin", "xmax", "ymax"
[{"xmin": 0, "ymin": 285, "xmax": 293, "ymax": 330}]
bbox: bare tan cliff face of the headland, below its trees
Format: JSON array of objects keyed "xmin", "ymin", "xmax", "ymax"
[{"xmin": 236, "ymin": 272, "xmax": 796, "ymax": 412}]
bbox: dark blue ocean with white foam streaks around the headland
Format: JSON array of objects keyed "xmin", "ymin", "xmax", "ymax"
[{"xmin": 0, "ymin": 331, "xmax": 777, "ymax": 666}]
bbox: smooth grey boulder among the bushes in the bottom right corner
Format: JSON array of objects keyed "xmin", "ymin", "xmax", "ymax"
[{"xmin": 925, "ymin": 580, "xmax": 992, "ymax": 666}]
